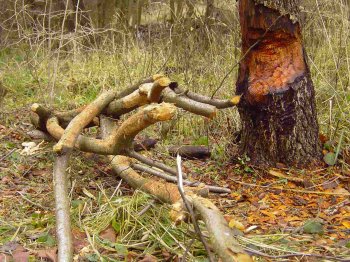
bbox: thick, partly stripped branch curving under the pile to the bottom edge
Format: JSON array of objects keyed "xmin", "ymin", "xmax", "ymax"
[{"xmin": 101, "ymin": 118, "xmax": 252, "ymax": 261}]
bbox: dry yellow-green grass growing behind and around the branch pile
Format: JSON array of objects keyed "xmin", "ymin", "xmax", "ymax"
[{"xmin": 0, "ymin": 0, "xmax": 350, "ymax": 261}]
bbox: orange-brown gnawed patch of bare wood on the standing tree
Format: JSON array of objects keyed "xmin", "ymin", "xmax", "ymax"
[{"xmin": 248, "ymin": 32, "xmax": 306, "ymax": 102}]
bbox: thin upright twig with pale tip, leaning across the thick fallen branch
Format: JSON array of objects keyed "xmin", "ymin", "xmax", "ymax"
[{"xmin": 176, "ymin": 154, "xmax": 214, "ymax": 262}]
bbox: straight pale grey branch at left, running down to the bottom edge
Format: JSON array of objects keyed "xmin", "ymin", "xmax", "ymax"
[{"xmin": 53, "ymin": 153, "xmax": 73, "ymax": 262}]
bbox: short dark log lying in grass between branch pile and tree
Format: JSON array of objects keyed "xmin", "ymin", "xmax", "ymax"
[{"xmin": 168, "ymin": 145, "xmax": 211, "ymax": 159}]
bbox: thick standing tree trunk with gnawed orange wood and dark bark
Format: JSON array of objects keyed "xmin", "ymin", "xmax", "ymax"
[{"xmin": 236, "ymin": 0, "xmax": 321, "ymax": 166}]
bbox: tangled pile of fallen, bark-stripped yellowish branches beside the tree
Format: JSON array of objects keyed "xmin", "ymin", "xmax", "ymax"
[{"xmin": 31, "ymin": 74, "xmax": 251, "ymax": 261}]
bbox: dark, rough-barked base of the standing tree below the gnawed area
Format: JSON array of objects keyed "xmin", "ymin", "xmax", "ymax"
[{"xmin": 239, "ymin": 72, "xmax": 321, "ymax": 167}]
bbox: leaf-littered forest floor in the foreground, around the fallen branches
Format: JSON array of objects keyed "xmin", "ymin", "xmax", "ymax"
[{"xmin": 0, "ymin": 101, "xmax": 350, "ymax": 261}]
